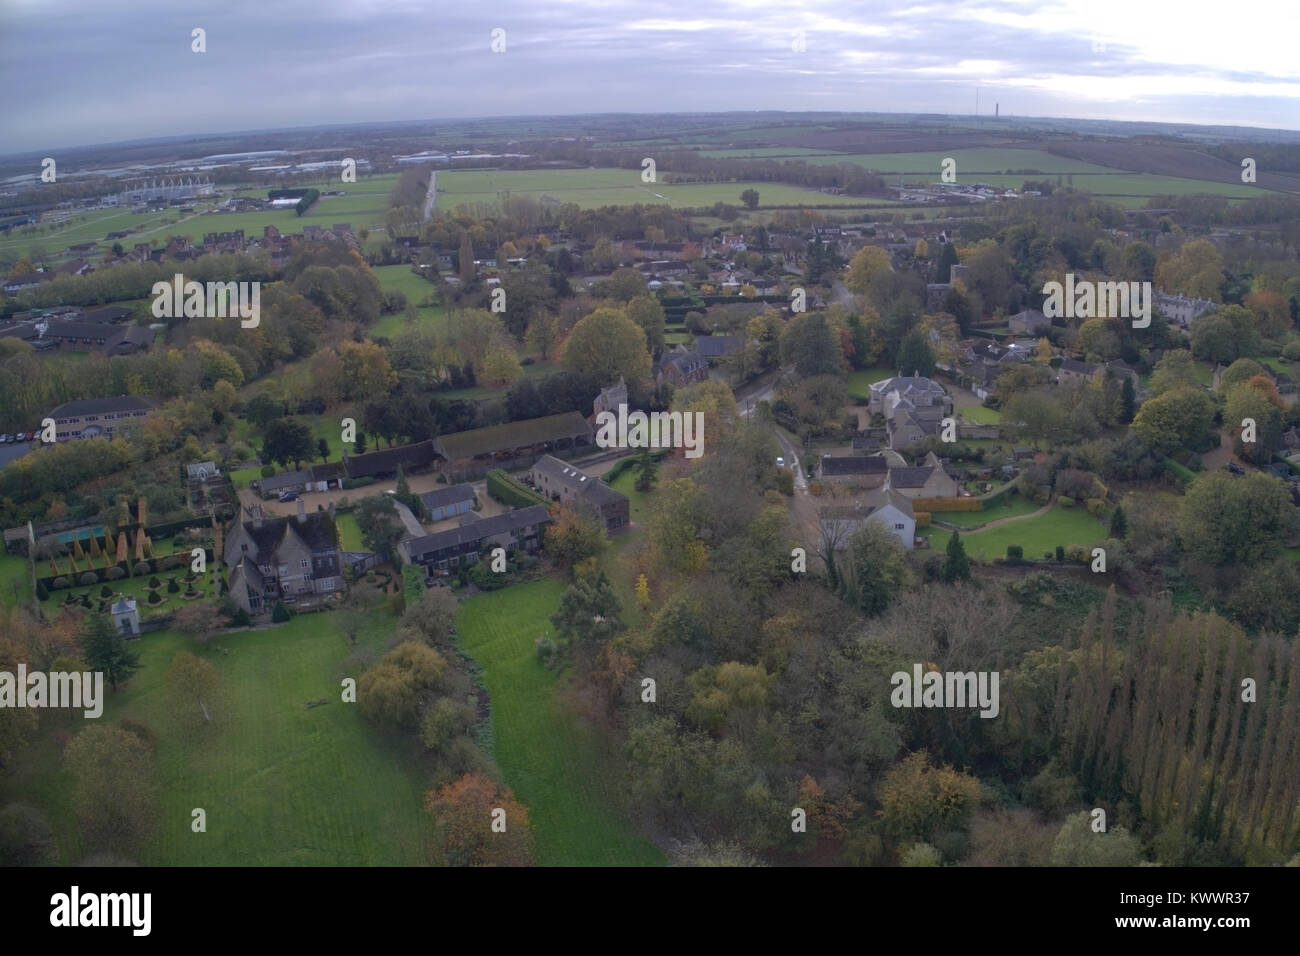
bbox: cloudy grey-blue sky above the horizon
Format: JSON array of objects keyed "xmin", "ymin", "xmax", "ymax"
[{"xmin": 0, "ymin": 0, "xmax": 1300, "ymax": 152}]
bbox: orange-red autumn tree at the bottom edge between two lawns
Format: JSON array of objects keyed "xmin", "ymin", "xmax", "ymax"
[{"xmin": 424, "ymin": 774, "xmax": 533, "ymax": 866}]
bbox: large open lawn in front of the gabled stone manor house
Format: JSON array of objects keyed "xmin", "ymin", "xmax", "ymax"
[{"xmin": 0, "ymin": 611, "xmax": 432, "ymax": 866}]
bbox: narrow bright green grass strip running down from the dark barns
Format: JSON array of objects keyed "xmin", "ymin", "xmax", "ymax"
[{"xmin": 454, "ymin": 574, "xmax": 663, "ymax": 866}]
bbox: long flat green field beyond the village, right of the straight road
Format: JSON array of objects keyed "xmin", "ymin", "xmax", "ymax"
[{"xmin": 438, "ymin": 169, "xmax": 881, "ymax": 211}]
